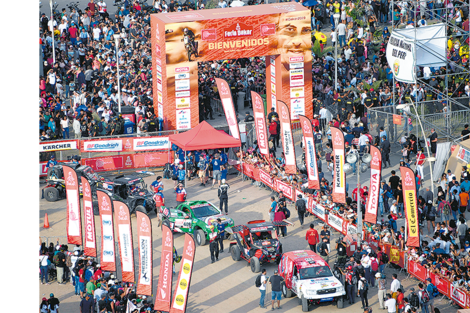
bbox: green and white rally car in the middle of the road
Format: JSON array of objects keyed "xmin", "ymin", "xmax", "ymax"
[{"xmin": 162, "ymin": 201, "xmax": 234, "ymax": 246}]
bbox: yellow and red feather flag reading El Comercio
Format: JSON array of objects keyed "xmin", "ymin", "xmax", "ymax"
[{"xmin": 400, "ymin": 166, "xmax": 419, "ymax": 247}]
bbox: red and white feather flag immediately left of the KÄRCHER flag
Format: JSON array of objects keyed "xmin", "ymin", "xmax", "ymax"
[{"xmin": 299, "ymin": 115, "xmax": 320, "ymax": 190}]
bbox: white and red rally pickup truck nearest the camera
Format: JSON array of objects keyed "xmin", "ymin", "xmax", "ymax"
[{"xmin": 279, "ymin": 250, "xmax": 346, "ymax": 312}]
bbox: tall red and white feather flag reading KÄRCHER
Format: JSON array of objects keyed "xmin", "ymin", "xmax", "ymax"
[{"xmin": 331, "ymin": 127, "xmax": 346, "ymax": 203}]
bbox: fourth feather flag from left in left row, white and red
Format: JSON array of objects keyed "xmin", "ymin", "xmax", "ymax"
[{"xmin": 113, "ymin": 201, "xmax": 134, "ymax": 282}]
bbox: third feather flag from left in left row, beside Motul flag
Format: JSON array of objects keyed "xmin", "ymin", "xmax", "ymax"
[{"xmin": 96, "ymin": 190, "xmax": 116, "ymax": 272}]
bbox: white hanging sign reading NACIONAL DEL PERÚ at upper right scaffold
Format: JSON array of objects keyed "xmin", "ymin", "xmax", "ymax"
[{"xmin": 386, "ymin": 31, "xmax": 416, "ymax": 83}]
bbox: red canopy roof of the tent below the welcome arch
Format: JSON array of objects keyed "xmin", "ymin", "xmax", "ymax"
[{"xmin": 170, "ymin": 121, "xmax": 241, "ymax": 151}]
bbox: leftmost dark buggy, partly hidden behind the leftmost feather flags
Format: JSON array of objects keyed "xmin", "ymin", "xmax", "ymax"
[{"xmin": 42, "ymin": 162, "xmax": 101, "ymax": 202}]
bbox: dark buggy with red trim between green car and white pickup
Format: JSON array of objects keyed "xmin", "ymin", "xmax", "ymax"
[{"xmin": 230, "ymin": 220, "xmax": 287, "ymax": 273}]
